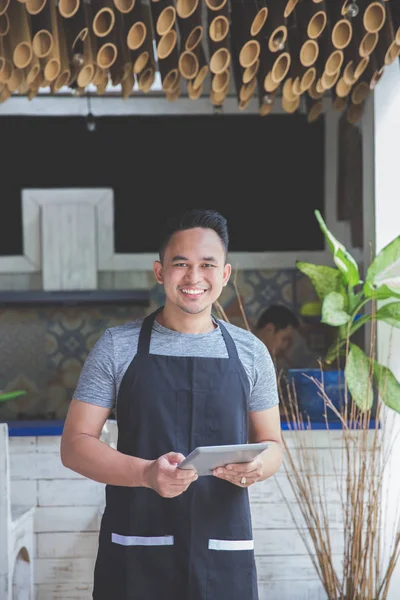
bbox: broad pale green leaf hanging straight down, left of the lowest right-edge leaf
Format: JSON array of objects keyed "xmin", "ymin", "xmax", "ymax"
[{"xmin": 344, "ymin": 344, "xmax": 373, "ymax": 411}]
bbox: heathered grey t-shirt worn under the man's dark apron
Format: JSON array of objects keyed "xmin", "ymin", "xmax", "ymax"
[{"xmin": 73, "ymin": 319, "xmax": 279, "ymax": 411}]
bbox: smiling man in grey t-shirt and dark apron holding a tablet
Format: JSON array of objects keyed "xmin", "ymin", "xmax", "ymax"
[{"xmin": 61, "ymin": 210, "xmax": 282, "ymax": 600}]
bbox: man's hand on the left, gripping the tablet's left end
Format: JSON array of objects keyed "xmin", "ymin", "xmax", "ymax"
[{"xmin": 144, "ymin": 452, "xmax": 198, "ymax": 498}]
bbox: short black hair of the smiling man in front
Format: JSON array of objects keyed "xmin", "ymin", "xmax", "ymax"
[{"xmin": 159, "ymin": 208, "xmax": 229, "ymax": 262}]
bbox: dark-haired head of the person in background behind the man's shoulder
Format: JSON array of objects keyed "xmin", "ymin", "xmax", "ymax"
[{"xmin": 254, "ymin": 304, "xmax": 300, "ymax": 362}]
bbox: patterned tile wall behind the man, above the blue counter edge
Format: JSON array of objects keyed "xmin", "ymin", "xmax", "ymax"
[{"xmin": 0, "ymin": 269, "xmax": 325, "ymax": 420}]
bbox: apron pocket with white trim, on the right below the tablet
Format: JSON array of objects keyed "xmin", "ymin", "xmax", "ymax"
[{"xmin": 206, "ymin": 539, "xmax": 255, "ymax": 600}]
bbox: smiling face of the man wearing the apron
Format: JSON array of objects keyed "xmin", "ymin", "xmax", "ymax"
[{"xmin": 154, "ymin": 227, "xmax": 231, "ymax": 314}]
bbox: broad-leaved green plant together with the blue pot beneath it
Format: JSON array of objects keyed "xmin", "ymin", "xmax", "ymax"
[{"xmin": 288, "ymin": 210, "xmax": 400, "ymax": 421}]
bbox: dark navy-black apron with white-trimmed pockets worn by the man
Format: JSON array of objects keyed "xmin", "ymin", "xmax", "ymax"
[{"xmin": 93, "ymin": 309, "xmax": 258, "ymax": 600}]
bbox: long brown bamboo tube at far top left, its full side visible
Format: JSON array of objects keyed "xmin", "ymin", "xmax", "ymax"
[{"xmin": 7, "ymin": 2, "xmax": 33, "ymax": 69}]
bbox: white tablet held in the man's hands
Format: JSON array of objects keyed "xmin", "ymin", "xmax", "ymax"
[{"xmin": 178, "ymin": 442, "xmax": 271, "ymax": 476}]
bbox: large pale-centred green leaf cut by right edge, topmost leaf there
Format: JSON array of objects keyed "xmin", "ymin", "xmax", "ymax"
[{"xmin": 364, "ymin": 235, "xmax": 400, "ymax": 300}]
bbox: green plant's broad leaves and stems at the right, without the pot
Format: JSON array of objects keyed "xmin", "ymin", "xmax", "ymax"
[{"xmin": 296, "ymin": 210, "xmax": 400, "ymax": 412}]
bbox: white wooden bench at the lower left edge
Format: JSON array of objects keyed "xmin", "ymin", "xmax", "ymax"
[{"xmin": 0, "ymin": 423, "xmax": 35, "ymax": 600}]
